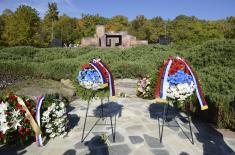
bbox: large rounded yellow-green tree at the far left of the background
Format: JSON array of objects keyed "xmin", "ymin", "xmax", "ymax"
[{"xmin": 3, "ymin": 5, "xmax": 40, "ymax": 46}]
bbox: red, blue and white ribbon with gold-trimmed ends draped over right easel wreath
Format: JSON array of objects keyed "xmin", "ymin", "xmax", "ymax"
[{"xmin": 156, "ymin": 57, "xmax": 208, "ymax": 110}]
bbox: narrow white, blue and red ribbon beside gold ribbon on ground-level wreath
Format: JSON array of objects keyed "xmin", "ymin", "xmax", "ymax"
[{"xmin": 35, "ymin": 96, "xmax": 44, "ymax": 146}]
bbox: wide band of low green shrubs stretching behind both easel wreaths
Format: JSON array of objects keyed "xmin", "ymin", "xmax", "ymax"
[{"xmin": 0, "ymin": 40, "xmax": 235, "ymax": 129}]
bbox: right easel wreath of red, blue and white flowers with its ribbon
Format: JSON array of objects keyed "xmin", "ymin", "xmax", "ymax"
[{"xmin": 156, "ymin": 57, "xmax": 208, "ymax": 110}]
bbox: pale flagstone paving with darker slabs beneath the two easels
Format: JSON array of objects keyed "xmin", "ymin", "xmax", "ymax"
[{"xmin": 0, "ymin": 79, "xmax": 235, "ymax": 155}]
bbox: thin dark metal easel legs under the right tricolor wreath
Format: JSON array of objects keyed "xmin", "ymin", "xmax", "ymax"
[{"xmin": 158, "ymin": 102, "xmax": 194, "ymax": 144}]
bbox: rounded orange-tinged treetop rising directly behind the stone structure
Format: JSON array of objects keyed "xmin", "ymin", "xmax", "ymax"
[{"xmin": 106, "ymin": 15, "xmax": 129, "ymax": 31}]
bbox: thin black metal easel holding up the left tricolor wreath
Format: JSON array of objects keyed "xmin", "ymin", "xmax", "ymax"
[{"xmin": 81, "ymin": 99, "xmax": 116, "ymax": 142}]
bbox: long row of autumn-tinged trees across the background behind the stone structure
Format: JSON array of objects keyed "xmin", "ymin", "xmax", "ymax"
[{"xmin": 0, "ymin": 3, "xmax": 235, "ymax": 47}]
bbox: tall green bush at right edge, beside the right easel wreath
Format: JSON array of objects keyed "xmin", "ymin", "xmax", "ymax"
[{"xmin": 185, "ymin": 40, "xmax": 235, "ymax": 129}]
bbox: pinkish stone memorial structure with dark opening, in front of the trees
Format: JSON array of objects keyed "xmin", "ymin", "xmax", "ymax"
[{"xmin": 81, "ymin": 25, "xmax": 148, "ymax": 47}]
